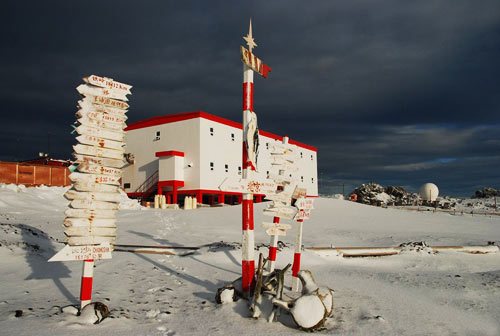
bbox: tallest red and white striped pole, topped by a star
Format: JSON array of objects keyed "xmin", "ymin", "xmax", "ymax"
[{"xmin": 241, "ymin": 23, "xmax": 256, "ymax": 293}]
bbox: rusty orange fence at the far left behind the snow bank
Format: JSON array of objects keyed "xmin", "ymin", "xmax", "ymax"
[{"xmin": 0, "ymin": 162, "xmax": 71, "ymax": 186}]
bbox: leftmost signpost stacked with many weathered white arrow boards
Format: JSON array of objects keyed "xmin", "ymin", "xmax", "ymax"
[{"xmin": 49, "ymin": 75, "xmax": 132, "ymax": 308}]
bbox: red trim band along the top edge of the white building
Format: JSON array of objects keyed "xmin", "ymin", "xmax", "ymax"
[{"xmin": 125, "ymin": 111, "xmax": 318, "ymax": 152}]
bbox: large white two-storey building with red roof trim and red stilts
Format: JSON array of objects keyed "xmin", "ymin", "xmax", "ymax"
[{"xmin": 122, "ymin": 111, "xmax": 318, "ymax": 204}]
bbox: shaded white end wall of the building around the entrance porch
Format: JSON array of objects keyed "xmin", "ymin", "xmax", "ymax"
[{"xmin": 122, "ymin": 118, "xmax": 200, "ymax": 193}]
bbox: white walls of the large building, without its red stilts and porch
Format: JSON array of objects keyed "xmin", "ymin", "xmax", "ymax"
[{"xmin": 123, "ymin": 112, "xmax": 318, "ymax": 196}]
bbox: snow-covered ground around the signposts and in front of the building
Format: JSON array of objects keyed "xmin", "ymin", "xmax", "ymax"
[{"xmin": 0, "ymin": 185, "xmax": 500, "ymax": 336}]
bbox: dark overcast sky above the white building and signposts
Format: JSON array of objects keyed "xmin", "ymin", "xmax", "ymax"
[{"xmin": 0, "ymin": 0, "xmax": 500, "ymax": 195}]
